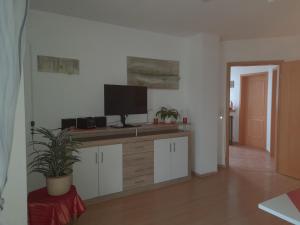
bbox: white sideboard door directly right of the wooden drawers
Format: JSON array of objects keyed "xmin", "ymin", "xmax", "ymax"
[{"xmin": 154, "ymin": 139, "xmax": 172, "ymax": 183}]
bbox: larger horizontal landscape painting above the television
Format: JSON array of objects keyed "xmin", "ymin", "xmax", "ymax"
[{"xmin": 127, "ymin": 57, "xmax": 180, "ymax": 89}]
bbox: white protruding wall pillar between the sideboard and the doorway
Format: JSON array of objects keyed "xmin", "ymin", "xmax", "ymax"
[{"xmin": 185, "ymin": 34, "xmax": 220, "ymax": 174}]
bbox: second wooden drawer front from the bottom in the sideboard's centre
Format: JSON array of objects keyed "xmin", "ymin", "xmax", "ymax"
[{"xmin": 123, "ymin": 162, "xmax": 154, "ymax": 179}]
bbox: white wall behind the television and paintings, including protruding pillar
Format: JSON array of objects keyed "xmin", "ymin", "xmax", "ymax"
[{"xmin": 26, "ymin": 11, "xmax": 220, "ymax": 190}]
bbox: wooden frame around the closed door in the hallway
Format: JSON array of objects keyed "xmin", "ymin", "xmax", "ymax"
[{"xmin": 239, "ymin": 72, "xmax": 273, "ymax": 150}]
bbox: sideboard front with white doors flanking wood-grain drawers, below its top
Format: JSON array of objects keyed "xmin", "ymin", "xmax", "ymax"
[{"xmin": 73, "ymin": 132, "xmax": 190, "ymax": 200}]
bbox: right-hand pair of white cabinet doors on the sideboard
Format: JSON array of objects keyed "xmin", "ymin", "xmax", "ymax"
[{"xmin": 154, "ymin": 137, "xmax": 188, "ymax": 183}]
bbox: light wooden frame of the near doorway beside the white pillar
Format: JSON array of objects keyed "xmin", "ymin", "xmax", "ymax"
[{"xmin": 225, "ymin": 60, "xmax": 284, "ymax": 168}]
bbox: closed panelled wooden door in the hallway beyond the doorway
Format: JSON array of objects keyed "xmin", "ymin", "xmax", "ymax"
[{"xmin": 239, "ymin": 73, "xmax": 268, "ymax": 149}]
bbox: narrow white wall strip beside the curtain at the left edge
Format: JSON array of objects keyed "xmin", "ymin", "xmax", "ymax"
[{"xmin": 0, "ymin": 79, "xmax": 27, "ymax": 225}]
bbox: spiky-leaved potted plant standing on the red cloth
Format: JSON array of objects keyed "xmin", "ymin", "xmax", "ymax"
[{"xmin": 28, "ymin": 128, "xmax": 80, "ymax": 196}]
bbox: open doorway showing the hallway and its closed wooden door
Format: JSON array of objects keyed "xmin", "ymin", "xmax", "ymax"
[{"xmin": 226, "ymin": 61, "xmax": 281, "ymax": 169}]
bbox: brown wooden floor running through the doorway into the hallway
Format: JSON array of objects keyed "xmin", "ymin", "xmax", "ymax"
[{"xmin": 77, "ymin": 147, "xmax": 300, "ymax": 225}]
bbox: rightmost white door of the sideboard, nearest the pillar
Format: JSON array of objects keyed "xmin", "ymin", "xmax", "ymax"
[{"xmin": 171, "ymin": 137, "xmax": 188, "ymax": 179}]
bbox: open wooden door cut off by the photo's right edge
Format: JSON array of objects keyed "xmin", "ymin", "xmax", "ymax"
[{"xmin": 277, "ymin": 61, "xmax": 300, "ymax": 179}]
